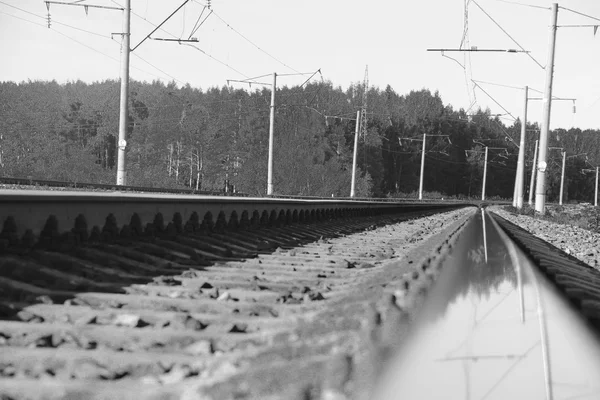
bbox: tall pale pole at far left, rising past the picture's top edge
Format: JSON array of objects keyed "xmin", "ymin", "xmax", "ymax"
[{"xmin": 117, "ymin": 0, "xmax": 131, "ymax": 186}]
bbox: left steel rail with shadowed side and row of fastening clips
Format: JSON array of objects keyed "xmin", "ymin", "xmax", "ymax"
[{"xmin": 0, "ymin": 190, "xmax": 465, "ymax": 244}]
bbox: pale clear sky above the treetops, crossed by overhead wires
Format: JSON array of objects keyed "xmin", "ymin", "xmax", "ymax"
[{"xmin": 0, "ymin": 0, "xmax": 600, "ymax": 129}]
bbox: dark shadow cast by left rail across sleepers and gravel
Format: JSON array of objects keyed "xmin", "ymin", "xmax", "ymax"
[{"xmin": 0, "ymin": 211, "xmax": 439, "ymax": 322}]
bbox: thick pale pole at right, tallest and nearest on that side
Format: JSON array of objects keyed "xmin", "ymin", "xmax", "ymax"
[{"xmin": 535, "ymin": 3, "xmax": 558, "ymax": 214}]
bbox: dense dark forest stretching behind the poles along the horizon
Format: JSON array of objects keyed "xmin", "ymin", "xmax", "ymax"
[{"xmin": 0, "ymin": 80, "xmax": 600, "ymax": 201}]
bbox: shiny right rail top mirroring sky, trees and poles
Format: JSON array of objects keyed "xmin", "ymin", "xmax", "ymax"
[{"xmin": 374, "ymin": 214, "xmax": 600, "ymax": 400}]
